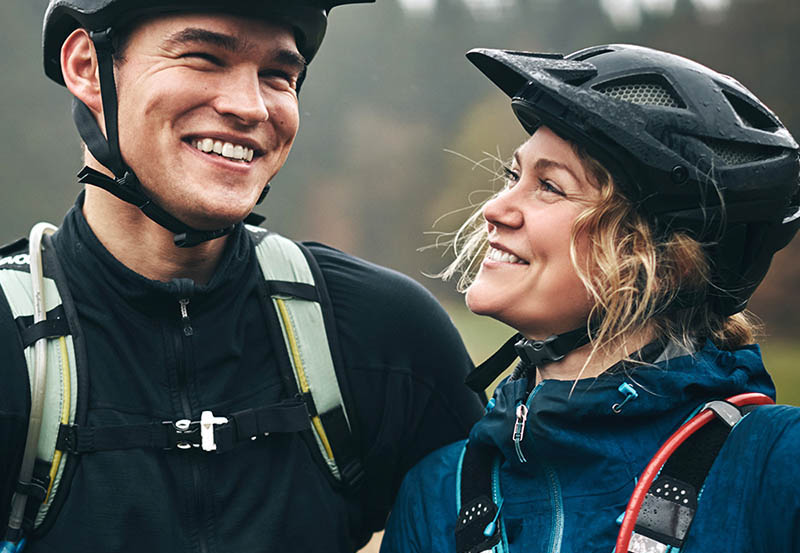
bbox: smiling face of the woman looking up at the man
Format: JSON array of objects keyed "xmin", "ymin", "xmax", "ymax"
[{"xmin": 467, "ymin": 127, "xmax": 600, "ymax": 339}]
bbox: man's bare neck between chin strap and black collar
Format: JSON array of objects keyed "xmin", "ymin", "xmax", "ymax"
[{"xmin": 83, "ymin": 186, "xmax": 227, "ymax": 284}]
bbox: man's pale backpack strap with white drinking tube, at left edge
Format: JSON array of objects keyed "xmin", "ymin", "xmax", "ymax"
[{"xmin": 0, "ymin": 223, "xmax": 78, "ymax": 541}]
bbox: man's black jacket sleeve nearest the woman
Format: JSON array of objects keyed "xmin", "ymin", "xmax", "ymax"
[{"xmin": 306, "ymin": 243, "xmax": 483, "ymax": 530}]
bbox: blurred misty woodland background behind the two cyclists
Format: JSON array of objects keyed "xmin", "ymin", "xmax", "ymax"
[{"xmin": 0, "ymin": 0, "xmax": 800, "ymax": 548}]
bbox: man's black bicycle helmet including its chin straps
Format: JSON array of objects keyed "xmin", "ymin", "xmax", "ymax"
[{"xmin": 42, "ymin": 0, "xmax": 374, "ymax": 247}]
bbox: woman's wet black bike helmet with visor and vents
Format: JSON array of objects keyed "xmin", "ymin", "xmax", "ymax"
[{"xmin": 467, "ymin": 45, "xmax": 800, "ymax": 315}]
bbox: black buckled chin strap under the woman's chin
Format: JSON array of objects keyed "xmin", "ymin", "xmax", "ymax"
[{"xmin": 464, "ymin": 327, "xmax": 590, "ymax": 394}]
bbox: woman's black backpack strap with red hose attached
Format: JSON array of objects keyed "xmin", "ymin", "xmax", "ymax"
[{"xmin": 615, "ymin": 393, "xmax": 773, "ymax": 553}]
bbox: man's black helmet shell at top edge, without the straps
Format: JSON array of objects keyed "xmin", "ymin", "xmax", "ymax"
[{"xmin": 42, "ymin": 0, "xmax": 374, "ymax": 85}]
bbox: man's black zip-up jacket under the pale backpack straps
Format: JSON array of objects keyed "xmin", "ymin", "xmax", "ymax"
[{"xmin": 0, "ymin": 199, "xmax": 481, "ymax": 553}]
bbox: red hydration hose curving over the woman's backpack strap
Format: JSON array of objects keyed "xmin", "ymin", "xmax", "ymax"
[{"xmin": 614, "ymin": 392, "xmax": 774, "ymax": 553}]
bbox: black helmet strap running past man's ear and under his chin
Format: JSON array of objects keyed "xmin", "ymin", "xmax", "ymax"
[{"xmin": 72, "ymin": 28, "xmax": 269, "ymax": 248}]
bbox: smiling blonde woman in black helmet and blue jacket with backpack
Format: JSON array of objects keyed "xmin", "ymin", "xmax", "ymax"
[{"xmin": 382, "ymin": 45, "xmax": 800, "ymax": 553}]
